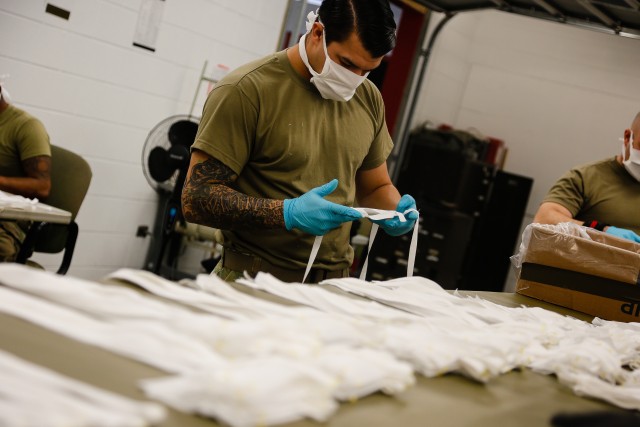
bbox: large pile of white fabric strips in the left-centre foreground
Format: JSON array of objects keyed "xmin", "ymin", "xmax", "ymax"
[{"xmin": 0, "ymin": 265, "xmax": 415, "ymax": 426}]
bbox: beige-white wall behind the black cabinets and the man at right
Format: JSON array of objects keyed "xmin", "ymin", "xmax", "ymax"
[{"xmin": 413, "ymin": 11, "xmax": 640, "ymax": 290}]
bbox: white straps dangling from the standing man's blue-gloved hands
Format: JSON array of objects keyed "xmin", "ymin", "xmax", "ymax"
[{"xmin": 302, "ymin": 208, "xmax": 420, "ymax": 283}]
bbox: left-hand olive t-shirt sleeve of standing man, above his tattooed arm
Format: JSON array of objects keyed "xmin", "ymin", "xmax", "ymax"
[{"xmin": 191, "ymin": 84, "xmax": 258, "ymax": 174}]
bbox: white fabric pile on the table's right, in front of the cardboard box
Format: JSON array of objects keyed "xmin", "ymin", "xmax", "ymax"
[{"xmin": 234, "ymin": 275, "xmax": 640, "ymax": 409}]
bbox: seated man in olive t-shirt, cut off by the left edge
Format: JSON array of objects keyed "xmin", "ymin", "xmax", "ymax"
[{"xmin": 0, "ymin": 87, "xmax": 51, "ymax": 261}]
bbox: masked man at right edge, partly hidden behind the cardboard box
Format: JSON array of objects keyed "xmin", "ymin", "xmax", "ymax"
[{"xmin": 533, "ymin": 113, "xmax": 640, "ymax": 243}]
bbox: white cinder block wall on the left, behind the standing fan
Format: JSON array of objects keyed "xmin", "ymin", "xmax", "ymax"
[{"xmin": 0, "ymin": 0, "xmax": 287, "ymax": 279}]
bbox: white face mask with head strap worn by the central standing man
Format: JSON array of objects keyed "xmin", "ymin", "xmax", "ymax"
[{"xmin": 298, "ymin": 12, "xmax": 369, "ymax": 101}]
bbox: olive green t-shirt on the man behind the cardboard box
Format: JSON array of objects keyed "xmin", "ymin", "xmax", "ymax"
[{"xmin": 543, "ymin": 157, "xmax": 640, "ymax": 234}]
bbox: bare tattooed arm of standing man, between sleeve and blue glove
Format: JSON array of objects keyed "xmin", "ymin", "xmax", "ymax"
[{"xmin": 182, "ymin": 150, "xmax": 284, "ymax": 230}]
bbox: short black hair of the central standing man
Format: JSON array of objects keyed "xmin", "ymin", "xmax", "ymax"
[{"xmin": 318, "ymin": 0, "xmax": 396, "ymax": 58}]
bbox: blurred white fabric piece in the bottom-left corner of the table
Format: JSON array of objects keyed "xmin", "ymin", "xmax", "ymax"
[{"xmin": 0, "ymin": 351, "xmax": 166, "ymax": 427}]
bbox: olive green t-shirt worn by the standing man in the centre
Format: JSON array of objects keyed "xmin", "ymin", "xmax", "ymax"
[{"xmin": 192, "ymin": 51, "xmax": 393, "ymax": 270}]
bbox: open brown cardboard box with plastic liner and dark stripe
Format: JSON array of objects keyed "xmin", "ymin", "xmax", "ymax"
[{"xmin": 514, "ymin": 224, "xmax": 640, "ymax": 322}]
